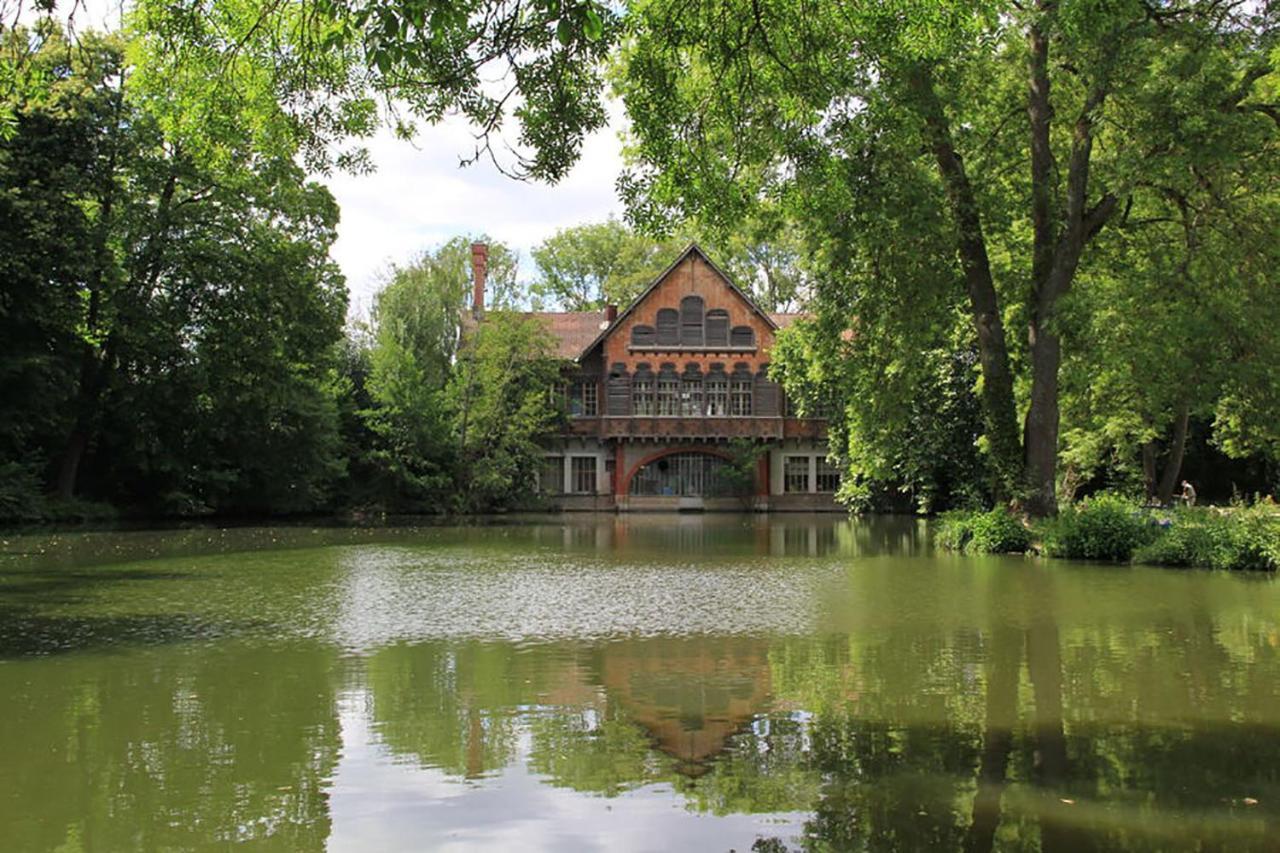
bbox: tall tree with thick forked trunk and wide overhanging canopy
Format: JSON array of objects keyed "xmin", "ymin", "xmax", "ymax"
[{"xmin": 618, "ymin": 0, "xmax": 1276, "ymax": 515}]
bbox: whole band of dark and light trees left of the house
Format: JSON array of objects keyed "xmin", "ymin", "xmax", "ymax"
[{"xmin": 0, "ymin": 33, "xmax": 558, "ymax": 521}]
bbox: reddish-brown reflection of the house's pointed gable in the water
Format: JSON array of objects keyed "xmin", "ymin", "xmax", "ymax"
[{"xmin": 600, "ymin": 638, "xmax": 772, "ymax": 775}]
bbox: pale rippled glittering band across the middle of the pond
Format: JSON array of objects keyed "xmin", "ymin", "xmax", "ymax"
[{"xmin": 337, "ymin": 548, "xmax": 827, "ymax": 648}]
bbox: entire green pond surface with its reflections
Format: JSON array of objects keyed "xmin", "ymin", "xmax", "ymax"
[{"xmin": 0, "ymin": 515, "xmax": 1280, "ymax": 853}]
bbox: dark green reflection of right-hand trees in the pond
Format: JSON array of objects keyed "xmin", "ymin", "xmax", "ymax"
[{"xmin": 752, "ymin": 558, "xmax": 1280, "ymax": 852}]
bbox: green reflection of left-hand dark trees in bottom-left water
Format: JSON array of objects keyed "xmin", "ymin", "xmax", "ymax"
[{"xmin": 0, "ymin": 644, "xmax": 339, "ymax": 850}]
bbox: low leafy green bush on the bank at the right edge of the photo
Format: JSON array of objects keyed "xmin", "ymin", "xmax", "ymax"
[{"xmin": 1135, "ymin": 505, "xmax": 1280, "ymax": 571}]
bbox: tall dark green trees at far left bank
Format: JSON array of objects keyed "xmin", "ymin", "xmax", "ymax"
[{"xmin": 0, "ymin": 33, "xmax": 347, "ymax": 516}]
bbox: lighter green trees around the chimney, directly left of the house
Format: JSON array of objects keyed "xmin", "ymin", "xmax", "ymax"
[{"xmin": 343, "ymin": 237, "xmax": 562, "ymax": 512}]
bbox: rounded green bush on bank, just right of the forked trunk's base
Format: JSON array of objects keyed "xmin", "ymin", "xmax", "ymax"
[{"xmin": 1038, "ymin": 494, "xmax": 1157, "ymax": 562}]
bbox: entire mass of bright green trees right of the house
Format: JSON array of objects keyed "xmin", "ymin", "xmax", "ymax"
[{"xmin": 617, "ymin": 0, "xmax": 1280, "ymax": 515}]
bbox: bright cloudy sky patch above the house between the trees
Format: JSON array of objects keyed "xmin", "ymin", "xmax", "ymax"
[{"xmin": 323, "ymin": 111, "xmax": 622, "ymax": 314}]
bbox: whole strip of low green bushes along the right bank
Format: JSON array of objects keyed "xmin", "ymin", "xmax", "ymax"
[{"xmin": 936, "ymin": 493, "xmax": 1280, "ymax": 571}]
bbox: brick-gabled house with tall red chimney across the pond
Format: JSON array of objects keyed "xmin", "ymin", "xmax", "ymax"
[{"xmin": 472, "ymin": 243, "xmax": 837, "ymax": 510}]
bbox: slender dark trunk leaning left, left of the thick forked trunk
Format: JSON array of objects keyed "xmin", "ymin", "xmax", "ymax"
[{"xmin": 908, "ymin": 65, "xmax": 1021, "ymax": 501}]
